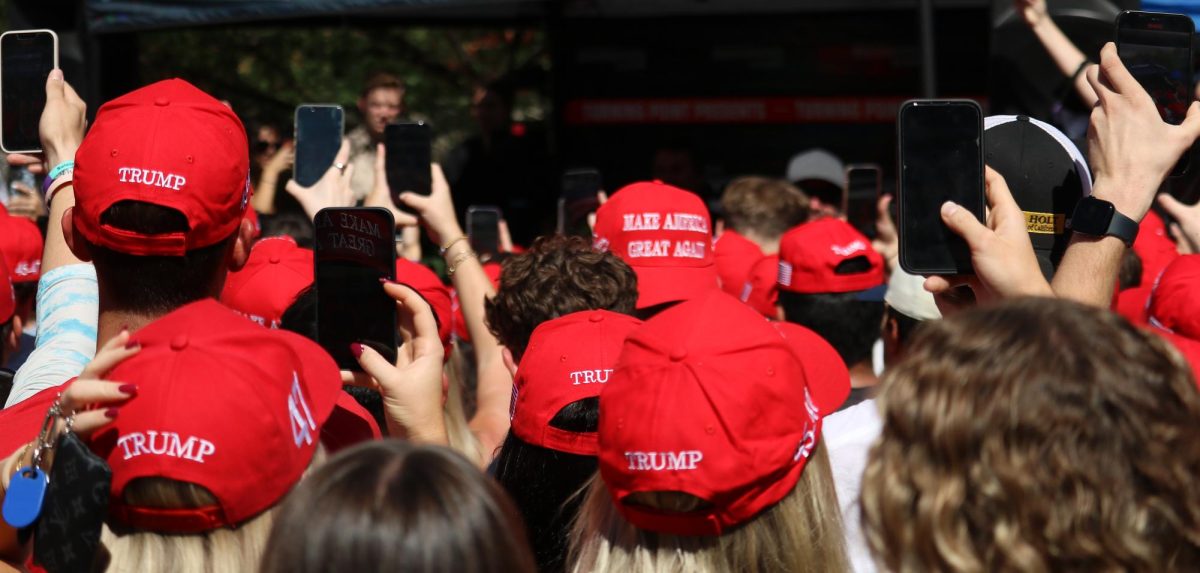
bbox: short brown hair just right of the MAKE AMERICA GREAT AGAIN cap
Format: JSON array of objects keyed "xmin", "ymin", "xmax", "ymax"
[{"xmin": 721, "ymin": 176, "xmax": 809, "ymax": 239}]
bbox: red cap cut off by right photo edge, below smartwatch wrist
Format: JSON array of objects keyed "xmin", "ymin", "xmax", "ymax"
[{"xmin": 1146, "ymin": 254, "xmax": 1200, "ymax": 340}]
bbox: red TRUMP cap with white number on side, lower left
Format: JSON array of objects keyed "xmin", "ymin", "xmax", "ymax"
[{"xmin": 91, "ymin": 298, "xmax": 342, "ymax": 533}]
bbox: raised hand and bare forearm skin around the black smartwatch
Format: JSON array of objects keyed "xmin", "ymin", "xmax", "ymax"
[{"xmin": 1054, "ymin": 43, "xmax": 1200, "ymax": 308}]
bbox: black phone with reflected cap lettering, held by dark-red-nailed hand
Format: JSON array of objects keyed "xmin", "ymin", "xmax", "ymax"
[{"xmin": 313, "ymin": 207, "xmax": 396, "ymax": 370}]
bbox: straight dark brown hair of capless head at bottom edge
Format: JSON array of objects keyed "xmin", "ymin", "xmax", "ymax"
[{"xmin": 260, "ymin": 440, "xmax": 534, "ymax": 573}]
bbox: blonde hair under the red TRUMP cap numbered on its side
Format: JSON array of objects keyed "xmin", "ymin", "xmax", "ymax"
[{"xmin": 100, "ymin": 447, "xmax": 325, "ymax": 573}]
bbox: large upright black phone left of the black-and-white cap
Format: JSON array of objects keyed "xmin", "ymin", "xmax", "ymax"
[{"xmin": 899, "ymin": 101, "xmax": 984, "ymax": 275}]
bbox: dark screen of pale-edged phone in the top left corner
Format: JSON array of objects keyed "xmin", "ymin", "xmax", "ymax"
[{"xmin": 0, "ymin": 31, "xmax": 55, "ymax": 152}]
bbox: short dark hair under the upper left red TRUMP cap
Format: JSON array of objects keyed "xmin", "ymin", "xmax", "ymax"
[{"xmin": 80, "ymin": 201, "xmax": 238, "ymax": 314}]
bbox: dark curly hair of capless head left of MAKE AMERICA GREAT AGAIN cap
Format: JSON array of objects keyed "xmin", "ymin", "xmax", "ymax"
[{"xmin": 484, "ymin": 235, "xmax": 637, "ymax": 360}]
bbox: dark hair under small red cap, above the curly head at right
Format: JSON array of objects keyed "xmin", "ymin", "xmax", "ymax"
[{"xmin": 779, "ymin": 290, "xmax": 883, "ymax": 367}]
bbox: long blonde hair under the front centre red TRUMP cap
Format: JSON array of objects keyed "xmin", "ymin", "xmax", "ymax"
[{"xmin": 568, "ymin": 445, "xmax": 850, "ymax": 573}]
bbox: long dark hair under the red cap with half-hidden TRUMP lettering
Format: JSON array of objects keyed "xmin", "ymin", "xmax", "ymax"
[{"xmin": 496, "ymin": 398, "xmax": 600, "ymax": 573}]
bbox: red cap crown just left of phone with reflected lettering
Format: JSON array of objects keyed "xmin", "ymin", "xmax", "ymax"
[{"xmin": 221, "ymin": 236, "xmax": 313, "ymax": 328}]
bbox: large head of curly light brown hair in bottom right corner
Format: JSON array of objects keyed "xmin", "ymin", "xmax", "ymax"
[{"xmin": 862, "ymin": 300, "xmax": 1200, "ymax": 572}]
